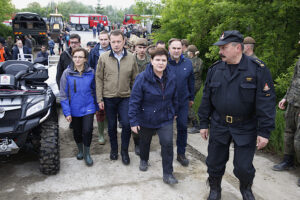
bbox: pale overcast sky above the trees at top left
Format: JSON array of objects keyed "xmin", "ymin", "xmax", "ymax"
[{"xmin": 12, "ymin": 0, "xmax": 134, "ymax": 9}]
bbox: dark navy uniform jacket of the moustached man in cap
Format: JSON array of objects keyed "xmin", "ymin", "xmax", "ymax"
[{"xmin": 198, "ymin": 55, "xmax": 276, "ymax": 145}]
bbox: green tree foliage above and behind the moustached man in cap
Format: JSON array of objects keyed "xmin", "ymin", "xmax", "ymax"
[{"xmin": 154, "ymin": 0, "xmax": 300, "ymax": 83}]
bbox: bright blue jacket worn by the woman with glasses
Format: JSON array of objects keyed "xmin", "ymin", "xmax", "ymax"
[{"xmin": 60, "ymin": 64, "xmax": 99, "ymax": 117}]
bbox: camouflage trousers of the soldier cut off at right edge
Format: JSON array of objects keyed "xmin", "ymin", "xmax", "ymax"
[{"xmin": 284, "ymin": 104, "xmax": 300, "ymax": 162}]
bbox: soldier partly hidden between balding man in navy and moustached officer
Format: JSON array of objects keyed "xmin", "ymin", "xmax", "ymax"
[{"xmin": 187, "ymin": 45, "xmax": 203, "ymax": 133}]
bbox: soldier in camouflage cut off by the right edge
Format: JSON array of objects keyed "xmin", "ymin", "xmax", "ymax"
[{"xmin": 273, "ymin": 41, "xmax": 300, "ymax": 187}]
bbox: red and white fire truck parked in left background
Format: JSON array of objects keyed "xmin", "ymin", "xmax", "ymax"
[{"xmin": 70, "ymin": 14, "xmax": 108, "ymax": 31}]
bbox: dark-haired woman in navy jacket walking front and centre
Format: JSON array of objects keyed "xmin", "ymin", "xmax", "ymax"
[{"xmin": 128, "ymin": 48, "xmax": 178, "ymax": 184}]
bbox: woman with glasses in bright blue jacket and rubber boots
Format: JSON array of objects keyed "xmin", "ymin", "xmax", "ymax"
[{"xmin": 60, "ymin": 48, "xmax": 99, "ymax": 166}]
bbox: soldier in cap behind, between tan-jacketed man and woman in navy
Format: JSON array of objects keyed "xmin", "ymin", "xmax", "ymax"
[{"xmin": 132, "ymin": 38, "xmax": 150, "ymax": 155}]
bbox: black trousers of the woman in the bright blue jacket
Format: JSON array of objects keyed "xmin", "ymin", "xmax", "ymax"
[{"xmin": 72, "ymin": 114, "xmax": 94, "ymax": 147}]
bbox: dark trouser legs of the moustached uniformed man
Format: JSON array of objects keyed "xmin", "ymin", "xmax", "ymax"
[{"xmin": 206, "ymin": 137, "xmax": 256, "ymax": 184}]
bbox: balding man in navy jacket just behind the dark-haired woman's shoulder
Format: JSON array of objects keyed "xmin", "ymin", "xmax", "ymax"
[{"xmin": 168, "ymin": 38, "xmax": 194, "ymax": 167}]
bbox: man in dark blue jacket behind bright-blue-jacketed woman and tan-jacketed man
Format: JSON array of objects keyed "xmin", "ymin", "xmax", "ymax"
[{"xmin": 88, "ymin": 31, "xmax": 110, "ymax": 145}]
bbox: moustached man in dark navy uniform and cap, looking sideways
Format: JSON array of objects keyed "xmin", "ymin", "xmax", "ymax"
[{"xmin": 198, "ymin": 30, "xmax": 276, "ymax": 200}]
